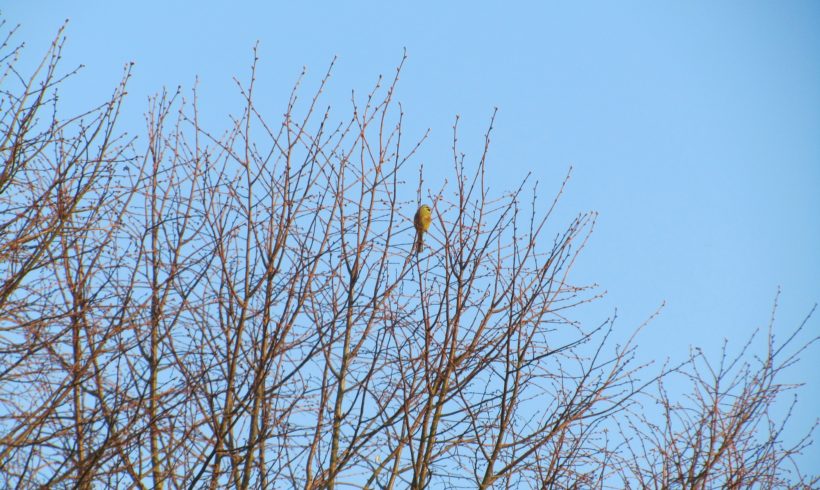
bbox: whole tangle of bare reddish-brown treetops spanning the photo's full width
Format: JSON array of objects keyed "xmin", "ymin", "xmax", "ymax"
[{"xmin": 0, "ymin": 20, "xmax": 817, "ymax": 489}]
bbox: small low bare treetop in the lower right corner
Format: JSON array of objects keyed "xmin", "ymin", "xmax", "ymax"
[{"xmin": 623, "ymin": 296, "xmax": 820, "ymax": 489}]
